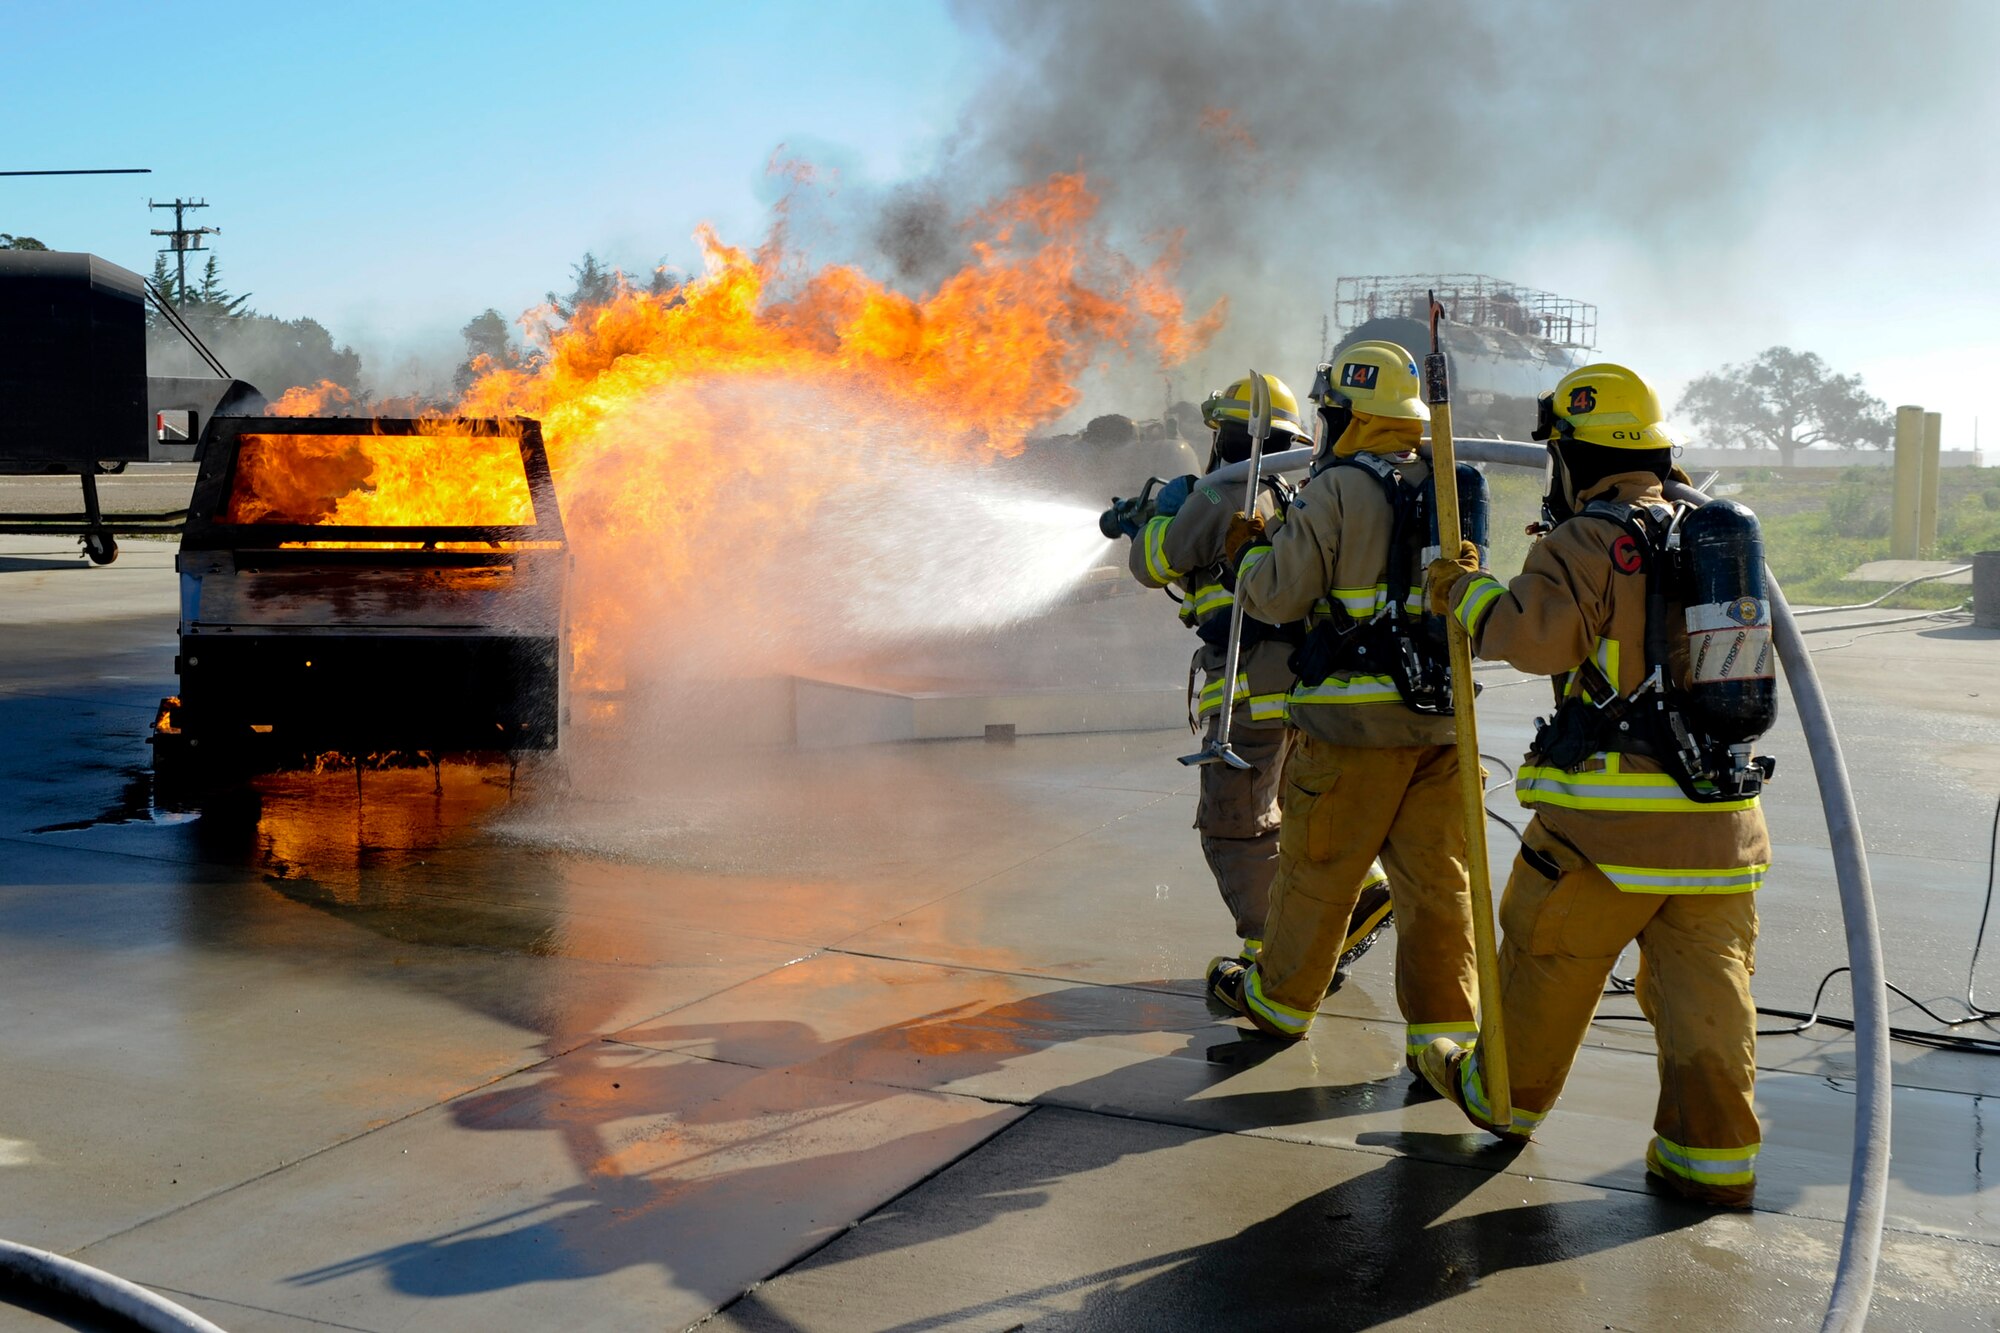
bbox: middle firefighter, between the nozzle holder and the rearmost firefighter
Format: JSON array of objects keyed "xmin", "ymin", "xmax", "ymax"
[{"xmin": 1208, "ymin": 342, "xmax": 1478, "ymax": 1069}]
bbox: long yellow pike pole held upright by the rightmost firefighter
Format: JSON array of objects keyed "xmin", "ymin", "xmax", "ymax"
[{"xmin": 1424, "ymin": 292, "xmax": 1514, "ymax": 1129}]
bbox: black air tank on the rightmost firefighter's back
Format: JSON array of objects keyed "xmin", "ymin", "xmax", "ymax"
[{"xmin": 1680, "ymin": 500, "xmax": 1778, "ymax": 745}]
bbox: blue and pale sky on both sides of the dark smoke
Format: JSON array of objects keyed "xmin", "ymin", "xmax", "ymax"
[{"xmin": 11, "ymin": 0, "xmax": 2000, "ymax": 454}]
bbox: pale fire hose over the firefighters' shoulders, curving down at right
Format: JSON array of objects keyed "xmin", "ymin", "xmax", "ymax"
[{"xmin": 1202, "ymin": 438, "xmax": 1892, "ymax": 1333}]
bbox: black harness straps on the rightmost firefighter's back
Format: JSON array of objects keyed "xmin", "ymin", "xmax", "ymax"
[{"xmin": 1534, "ymin": 500, "xmax": 1776, "ymax": 805}]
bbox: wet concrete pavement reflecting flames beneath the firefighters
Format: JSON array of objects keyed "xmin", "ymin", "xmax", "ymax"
[{"xmin": 0, "ymin": 538, "xmax": 2000, "ymax": 1329}]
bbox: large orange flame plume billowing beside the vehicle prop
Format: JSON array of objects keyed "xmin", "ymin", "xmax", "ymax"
[{"xmin": 254, "ymin": 174, "xmax": 1224, "ymax": 689}]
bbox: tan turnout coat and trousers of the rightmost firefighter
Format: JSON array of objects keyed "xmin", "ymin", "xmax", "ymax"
[{"xmin": 1452, "ymin": 472, "xmax": 1770, "ymax": 1205}]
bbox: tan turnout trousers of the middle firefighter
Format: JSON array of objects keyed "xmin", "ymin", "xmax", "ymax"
[{"xmin": 1244, "ymin": 733, "xmax": 1478, "ymax": 1053}]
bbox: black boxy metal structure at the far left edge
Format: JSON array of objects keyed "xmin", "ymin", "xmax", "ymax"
[{"xmin": 0, "ymin": 250, "xmax": 152, "ymax": 474}]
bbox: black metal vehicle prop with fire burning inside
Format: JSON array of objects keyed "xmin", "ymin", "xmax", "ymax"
[{"xmin": 152, "ymin": 416, "xmax": 570, "ymax": 791}]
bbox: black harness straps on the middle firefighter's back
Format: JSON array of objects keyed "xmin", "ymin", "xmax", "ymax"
[{"xmin": 1292, "ymin": 454, "xmax": 1452, "ymax": 717}]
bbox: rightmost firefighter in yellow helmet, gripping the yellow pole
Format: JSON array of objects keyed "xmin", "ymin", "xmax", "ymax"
[{"xmin": 1420, "ymin": 364, "xmax": 1776, "ymax": 1207}]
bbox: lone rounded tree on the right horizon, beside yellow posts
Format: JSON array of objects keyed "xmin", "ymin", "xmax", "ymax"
[{"xmin": 1674, "ymin": 346, "xmax": 1892, "ymax": 466}]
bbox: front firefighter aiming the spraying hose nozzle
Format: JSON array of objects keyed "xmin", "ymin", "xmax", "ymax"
[{"xmin": 1130, "ymin": 374, "xmax": 1388, "ymax": 976}]
